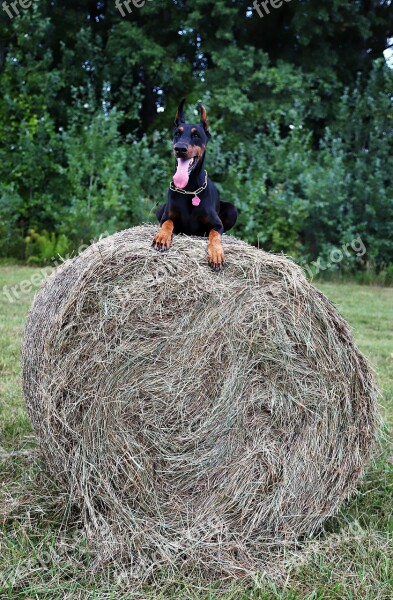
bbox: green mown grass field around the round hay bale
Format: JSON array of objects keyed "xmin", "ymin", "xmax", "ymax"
[{"xmin": 0, "ymin": 266, "xmax": 393, "ymax": 600}]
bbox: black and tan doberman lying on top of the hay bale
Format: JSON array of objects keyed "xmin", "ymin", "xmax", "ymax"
[{"xmin": 152, "ymin": 98, "xmax": 237, "ymax": 271}]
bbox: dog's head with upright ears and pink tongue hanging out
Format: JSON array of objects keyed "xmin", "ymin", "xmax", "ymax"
[{"xmin": 173, "ymin": 98, "xmax": 211, "ymax": 189}]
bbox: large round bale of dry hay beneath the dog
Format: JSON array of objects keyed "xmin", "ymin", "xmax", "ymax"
[{"xmin": 23, "ymin": 226, "xmax": 378, "ymax": 578}]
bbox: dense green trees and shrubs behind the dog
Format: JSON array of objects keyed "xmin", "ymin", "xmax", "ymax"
[{"xmin": 0, "ymin": 0, "xmax": 393, "ymax": 280}]
